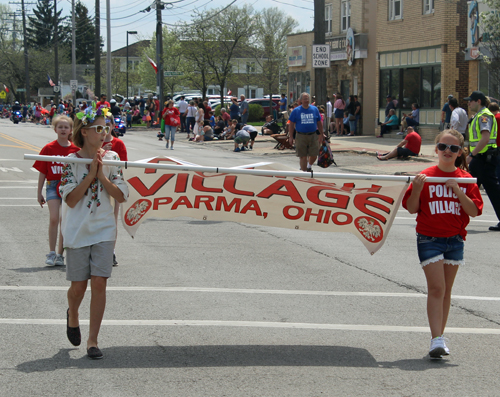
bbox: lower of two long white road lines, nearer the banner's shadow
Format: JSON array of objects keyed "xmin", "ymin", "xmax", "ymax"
[{"xmin": 0, "ymin": 318, "xmax": 500, "ymax": 335}]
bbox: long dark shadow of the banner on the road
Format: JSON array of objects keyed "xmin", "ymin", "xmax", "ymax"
[{"xmin": 16, "ymin": 345, "xmax": 379, "ymax": 373}]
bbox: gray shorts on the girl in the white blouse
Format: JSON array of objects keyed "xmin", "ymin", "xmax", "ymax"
[{"xmin": 66, "ymin": 241, "xmax": 115, "ymax": 281}]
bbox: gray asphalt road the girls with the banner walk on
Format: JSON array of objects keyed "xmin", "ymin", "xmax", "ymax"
[{"xmin": 0, "ymin": 120, "xmax": 500, "ymax": 396}]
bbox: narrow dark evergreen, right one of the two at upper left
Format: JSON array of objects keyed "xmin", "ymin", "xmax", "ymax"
[{"xmin": 71, "ymin": 1, "xmax": 97, "ymax": 64}]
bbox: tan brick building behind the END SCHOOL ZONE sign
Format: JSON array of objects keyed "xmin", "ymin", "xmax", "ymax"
[{"xmin": 287, "ymin": 0, "xmax": 377, "ymax": 135}]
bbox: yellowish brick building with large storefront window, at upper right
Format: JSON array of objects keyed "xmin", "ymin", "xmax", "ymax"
[{"xmin": 376, "ymin": 0, "xmax": 470, "ymax": 139}]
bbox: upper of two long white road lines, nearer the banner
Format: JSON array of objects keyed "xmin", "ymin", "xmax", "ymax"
[{"xmin": 0, "ymin": 285, "xmax": 500, "ymax": 301}]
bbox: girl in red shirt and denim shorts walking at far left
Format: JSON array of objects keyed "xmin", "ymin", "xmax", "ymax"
[{"xmin": 33, "ymin": 116, "xmax": 79, "ymax": 266}]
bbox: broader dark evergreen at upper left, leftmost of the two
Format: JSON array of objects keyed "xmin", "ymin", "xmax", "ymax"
[{"xmin": 26, "ymin": 0, "xmax": 71, "ymax": 50}]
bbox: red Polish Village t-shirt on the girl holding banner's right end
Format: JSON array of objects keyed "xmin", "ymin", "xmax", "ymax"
[{"xmin": 403, "ymin": 165, "xmax": 483, "ymax": 240}]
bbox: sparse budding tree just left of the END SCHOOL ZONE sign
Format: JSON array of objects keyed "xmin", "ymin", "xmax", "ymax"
[{"xmin": 255, "ymin": 7, "xmax": 298, "ymax": 113}]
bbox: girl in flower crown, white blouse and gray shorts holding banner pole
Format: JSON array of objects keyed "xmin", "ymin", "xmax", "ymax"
[{"xmin": 60, "ymin": 103, "xmax": 128, "ymax": 359}]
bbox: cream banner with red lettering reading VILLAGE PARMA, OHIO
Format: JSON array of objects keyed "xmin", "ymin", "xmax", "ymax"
[{"xmin": 122, "ymin": 157, "xmax": 410, "ymax": 255}]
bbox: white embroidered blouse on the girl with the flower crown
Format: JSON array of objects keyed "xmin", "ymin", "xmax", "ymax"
[{"xmin": 59, "ymin": 151, "xmax": 128, "ymax": 248}]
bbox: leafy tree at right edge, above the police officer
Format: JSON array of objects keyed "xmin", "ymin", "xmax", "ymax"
[{"xmin": 480, "ymin": 0, "xmax": 500, "ymax": 98}]
